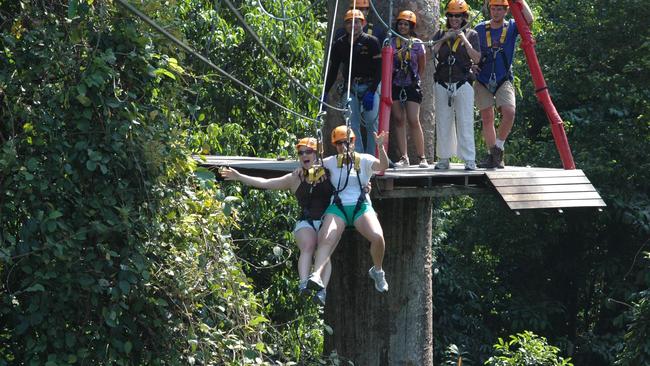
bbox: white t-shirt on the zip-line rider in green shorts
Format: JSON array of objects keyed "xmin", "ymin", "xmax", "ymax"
[{"xmin": 323, "ymin": 153, "xmax": 376, "ymax": 206}]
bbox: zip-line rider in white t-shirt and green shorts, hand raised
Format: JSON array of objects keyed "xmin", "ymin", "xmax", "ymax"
[{"xmin": 307, "ymin": 126, "xmax": 388, "ymax": 292}]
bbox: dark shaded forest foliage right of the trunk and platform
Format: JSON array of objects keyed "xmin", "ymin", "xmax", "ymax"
[{"xmin": 433, "ymin": 0, "xmax": 650, "ymax": 366}]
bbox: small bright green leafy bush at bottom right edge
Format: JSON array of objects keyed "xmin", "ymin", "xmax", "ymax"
[{"xmin": 485, "ymin": 331, "xmax": 573, "ymax": 366}]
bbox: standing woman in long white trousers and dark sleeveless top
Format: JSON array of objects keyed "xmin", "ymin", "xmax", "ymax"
[{"xmin": 433, "ymin": 0, "xmax": 481, "ymax": 170}]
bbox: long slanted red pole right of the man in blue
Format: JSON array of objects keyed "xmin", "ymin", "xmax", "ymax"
[{"xmin": 510, "ymin": 1, "xmax": 576, "ymax": 169}]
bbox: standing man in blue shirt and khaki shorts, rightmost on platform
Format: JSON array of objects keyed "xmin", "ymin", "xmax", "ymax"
[{"xmin": 474, "ymin": 0, "xmax": 533, "ymax": 169}]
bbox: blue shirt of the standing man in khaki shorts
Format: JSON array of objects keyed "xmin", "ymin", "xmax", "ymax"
[{"xmin": 474, "ymin": 19, "xmax": 519, "ymax": 85}]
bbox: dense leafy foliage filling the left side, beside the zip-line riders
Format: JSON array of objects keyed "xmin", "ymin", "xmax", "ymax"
[{"xmin": 0, "ymin": 0, "xmax": 330, "ymax": 365}]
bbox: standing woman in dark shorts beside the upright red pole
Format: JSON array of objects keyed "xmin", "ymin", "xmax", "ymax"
[{"xmin": 391, "ymin": 10, "xmax": 429, "ymax": 168}]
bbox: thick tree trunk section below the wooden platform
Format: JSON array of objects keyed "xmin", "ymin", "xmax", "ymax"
[{"xmin": 325, "ymin": 198, "xmax": 433, "ymax": 366}]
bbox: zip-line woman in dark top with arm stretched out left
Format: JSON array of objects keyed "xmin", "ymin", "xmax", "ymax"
[{"xmin": 220, "ymin": 137, "xmax": 334, "ymax": 304}]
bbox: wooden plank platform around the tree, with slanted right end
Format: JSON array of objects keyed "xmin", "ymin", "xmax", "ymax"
[{"xmin": 195, "ymin": 156, "xmax": 606, "ymax": 210}]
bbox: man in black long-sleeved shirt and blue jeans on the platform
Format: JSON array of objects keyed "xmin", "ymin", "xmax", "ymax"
[{"xmin": 325, "ymin": 9, "xmax": 381, "ymax": 155}]
